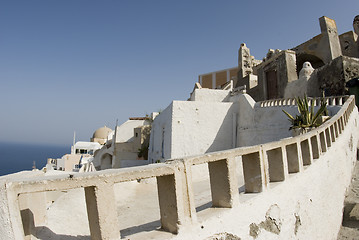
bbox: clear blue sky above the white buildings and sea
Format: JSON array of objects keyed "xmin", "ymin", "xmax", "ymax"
[{"xmin": 0, "ymin": 0, "xmax": 359, "ymax": 145}]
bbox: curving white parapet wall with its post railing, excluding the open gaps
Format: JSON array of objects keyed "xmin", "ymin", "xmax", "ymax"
[{"xmin": 0, "ymin": 96, "xmax": 359, "ymax": 240}]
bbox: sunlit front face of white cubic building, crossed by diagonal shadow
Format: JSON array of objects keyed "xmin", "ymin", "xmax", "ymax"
[{"xmin": 169, "ymin": 101, "xmax": 233, "ymax": 158}]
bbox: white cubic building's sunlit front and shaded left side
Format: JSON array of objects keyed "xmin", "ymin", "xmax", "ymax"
[{"xmin": 149, "ymin": 99, "xmax": 234, "ymax": 162}]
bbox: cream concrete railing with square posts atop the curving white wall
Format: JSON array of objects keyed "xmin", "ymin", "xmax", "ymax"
[{"xmin": 6, "ymin": 96, "xmax": 355, "ymax": 239}]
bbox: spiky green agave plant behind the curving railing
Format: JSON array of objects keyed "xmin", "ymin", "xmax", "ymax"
[{"xmin": 282, "ymin": 95, "xmax": 328, "ymax": 130}]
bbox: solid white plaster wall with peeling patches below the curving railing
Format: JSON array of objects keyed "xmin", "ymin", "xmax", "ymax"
[{"xmin": 173, "ymin": 110, "xmax": 359, "ymax": 240}]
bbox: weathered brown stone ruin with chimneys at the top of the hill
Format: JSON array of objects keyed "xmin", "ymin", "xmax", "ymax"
[{"xmin": 199, "ymin": 16, "xmax": 359, "ymax": 101}]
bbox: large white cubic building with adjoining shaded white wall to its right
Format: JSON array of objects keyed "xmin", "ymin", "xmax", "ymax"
[{"xmin": 149, "ymin": 89, "xmax": 346, "ymax": 163}]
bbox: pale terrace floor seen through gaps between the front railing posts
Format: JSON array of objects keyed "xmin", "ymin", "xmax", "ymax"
[{"xmin": 33, "ymin": 164, "xmax": 248, "ymax": 240}]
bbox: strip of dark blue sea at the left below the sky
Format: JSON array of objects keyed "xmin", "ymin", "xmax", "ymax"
[{"xmin": 0, "ymin": 142, "xmax": 71, "ymax": 176}]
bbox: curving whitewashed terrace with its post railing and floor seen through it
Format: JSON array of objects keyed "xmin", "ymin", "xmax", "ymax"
[{"xmin": 0, "ymin": 96, "xmax": 358, "ymax": 239}]
